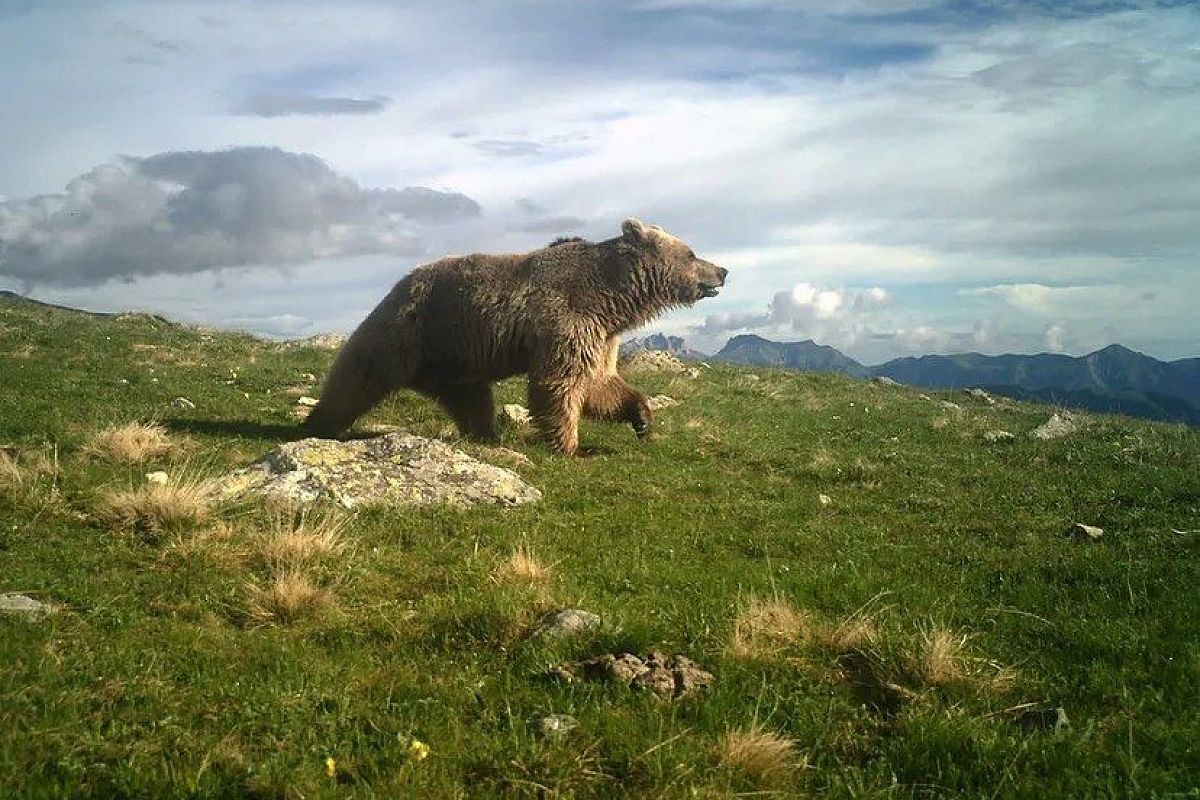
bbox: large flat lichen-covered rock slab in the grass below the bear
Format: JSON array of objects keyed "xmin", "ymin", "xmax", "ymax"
[{"xmin": 217, "ymin": 433, "xmax": 541, "ymax": 509}]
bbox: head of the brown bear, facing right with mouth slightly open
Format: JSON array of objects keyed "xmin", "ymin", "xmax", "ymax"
[{"xmin": 620, "ymin": 219, "xmax": 728, "ymax": 306}]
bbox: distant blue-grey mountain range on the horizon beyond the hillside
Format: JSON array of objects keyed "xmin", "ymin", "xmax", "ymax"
[{"xmin": 623, "ymin": 333, "xmax": 1200, "ymax": 425}]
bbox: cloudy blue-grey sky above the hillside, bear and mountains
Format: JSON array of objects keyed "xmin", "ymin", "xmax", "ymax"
[{"xmin": 0, "ymin": 0, "xmax": 1200, "ymax": 363}]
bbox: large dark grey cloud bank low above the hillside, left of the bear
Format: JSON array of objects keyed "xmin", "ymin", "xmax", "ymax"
[{"xmin": 0, "ymin": 148, "xmax": 480, "ymax": 287}]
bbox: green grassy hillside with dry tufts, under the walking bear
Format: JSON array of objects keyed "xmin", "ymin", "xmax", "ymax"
[{"xmin": 0, "ymin": 296, "xmax": 1200, "ymax": 798}]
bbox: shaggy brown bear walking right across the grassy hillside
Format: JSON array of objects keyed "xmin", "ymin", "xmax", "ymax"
[{"xmin": 302, "ymin": 219, "xmax": 727, "ymax": 455}]
